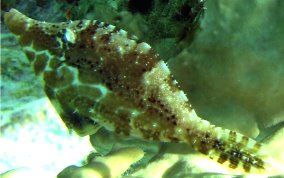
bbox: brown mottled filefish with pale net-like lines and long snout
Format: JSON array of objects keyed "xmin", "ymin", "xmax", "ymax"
[{"xmin": 4, "ymin": 9, "xmax": 268, "ymax": 173}]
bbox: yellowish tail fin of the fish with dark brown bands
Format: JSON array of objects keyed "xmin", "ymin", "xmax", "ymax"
[{"xmin": 186, "ymin": 121, "xmax": 268, "ymax": 174}]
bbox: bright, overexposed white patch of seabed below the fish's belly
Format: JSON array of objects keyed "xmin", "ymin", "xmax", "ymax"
[{"xmin": 0, "ymin": 97, "xmax": 93, "ymax": 177}]
